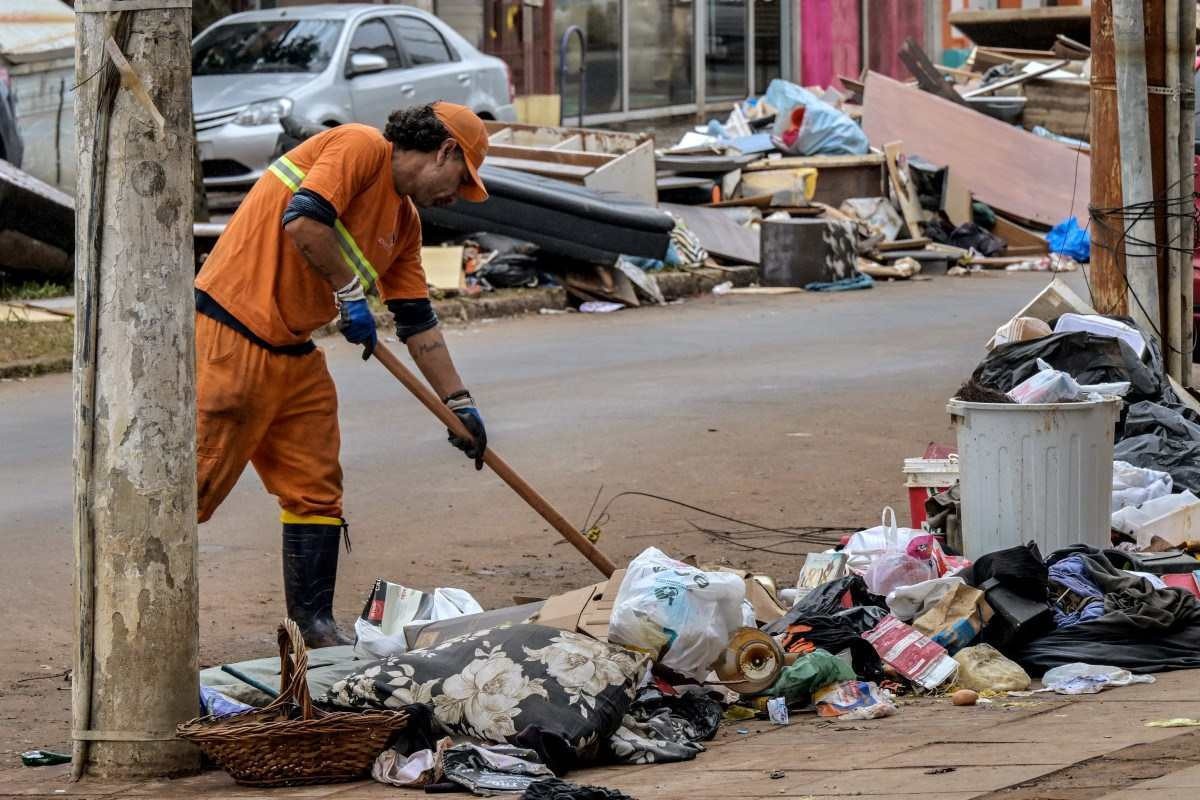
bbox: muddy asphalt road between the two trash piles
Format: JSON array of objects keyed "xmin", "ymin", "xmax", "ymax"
[{"xmin": 0, "ymin": 272, "xmax": 1082, "ymax": 764}]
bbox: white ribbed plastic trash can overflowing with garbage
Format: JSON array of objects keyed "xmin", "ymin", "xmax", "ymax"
[{"xmin": 946, "ymin": 397, "xmax": 1121, "ymax": 560}]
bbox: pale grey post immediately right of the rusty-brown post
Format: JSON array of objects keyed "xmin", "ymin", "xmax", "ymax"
[{"xmin": 1112, "ymin": 0, "xmax": 1162, "ymax": 336}]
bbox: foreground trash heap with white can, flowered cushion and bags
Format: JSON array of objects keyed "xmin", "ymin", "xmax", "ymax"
[{"xmin": 188, "ymin": 279, "xmax": 1200, "ymax": 798}]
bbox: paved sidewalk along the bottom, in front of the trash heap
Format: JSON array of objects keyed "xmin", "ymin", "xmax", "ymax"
[{"xmin": 0, "ymin": 672, "xmax": 1200, "ymax": 800}]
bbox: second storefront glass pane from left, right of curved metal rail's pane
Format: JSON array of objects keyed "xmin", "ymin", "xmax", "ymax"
[{"xmin": 629, "ymin": 0, "xmax": 696, "ymax": 108}]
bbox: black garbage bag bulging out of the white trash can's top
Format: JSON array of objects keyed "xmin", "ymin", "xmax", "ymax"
[{"xmin": 972, "ymin": 331, "xmax": 1161, "ymax": 403}]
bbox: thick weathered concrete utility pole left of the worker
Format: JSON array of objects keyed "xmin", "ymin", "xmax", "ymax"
[{"xmin": 72, "ymin": 0, "xmax": 199, "ymax": 778}]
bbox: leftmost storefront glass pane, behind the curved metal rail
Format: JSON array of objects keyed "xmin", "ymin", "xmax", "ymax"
[{"xmin": 553, "ymin": 0, "xmax": 620, "ymax": 118}]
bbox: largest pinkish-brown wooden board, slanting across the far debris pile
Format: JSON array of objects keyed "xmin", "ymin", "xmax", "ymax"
[{"xmin": 863, "ymin": 72, "xmax": 1091, "ymax": 225}]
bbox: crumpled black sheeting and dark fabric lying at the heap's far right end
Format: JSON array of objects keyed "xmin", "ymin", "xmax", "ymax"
[{"xmin": 1006, "ymin": 546, "xmax": 1200, "ymax": 675}]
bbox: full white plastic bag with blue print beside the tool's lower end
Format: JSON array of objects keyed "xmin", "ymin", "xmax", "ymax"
[{"xmin": 608, "ymin": 547, "xmax": 746, "ymax": 680}]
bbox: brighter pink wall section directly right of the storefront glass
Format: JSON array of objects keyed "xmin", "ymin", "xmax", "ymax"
[{"xmin": 796, "ymin": 0, "xmax": 863, "ymax": 86}]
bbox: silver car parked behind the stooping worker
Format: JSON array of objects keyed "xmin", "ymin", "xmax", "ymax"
[{"xmin": 192, "ymin": 5, "xmax": 516, "ymax": 190}]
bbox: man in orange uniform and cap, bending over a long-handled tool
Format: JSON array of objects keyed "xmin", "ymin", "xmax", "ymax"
[{"xmin": 196, "ymin": 102, "xmax": 487, "ymax": 646}]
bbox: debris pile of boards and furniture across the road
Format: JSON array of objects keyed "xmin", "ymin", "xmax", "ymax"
[{"xmin": 412, "ymin": 47, "xmax": 1090, "ymax": 309}]
